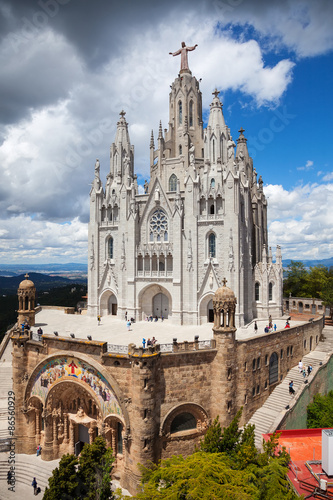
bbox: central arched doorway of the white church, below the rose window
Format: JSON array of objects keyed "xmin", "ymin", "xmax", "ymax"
[{"xmin": 138, "ymin": 284, "xmax": 172, "ymax": 320}]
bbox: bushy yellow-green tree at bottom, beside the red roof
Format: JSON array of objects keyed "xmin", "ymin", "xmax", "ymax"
[{"xmin": 136, "ymin": 411, "xmax": 298, "ymax": 500}]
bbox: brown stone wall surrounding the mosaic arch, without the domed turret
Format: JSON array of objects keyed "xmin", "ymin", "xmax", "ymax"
[{"xmin": 12, "ymin": 314, "xmax": 322, "ymax": 492}]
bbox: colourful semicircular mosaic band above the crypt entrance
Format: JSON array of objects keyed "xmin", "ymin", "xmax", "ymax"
[{"xmin": 31, "ymin": 356, "xmax": 123, "ymax": 417}]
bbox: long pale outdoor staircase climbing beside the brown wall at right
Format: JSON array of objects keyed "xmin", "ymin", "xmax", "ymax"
[{"xmin": 248, "ymin": 326, "xmax": 333, "ymax": 449}]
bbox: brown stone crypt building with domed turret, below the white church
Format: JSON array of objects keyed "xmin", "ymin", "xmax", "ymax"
[{"xmin": 12, "ymin": 286, "xmax": 323, "ymax": 492}]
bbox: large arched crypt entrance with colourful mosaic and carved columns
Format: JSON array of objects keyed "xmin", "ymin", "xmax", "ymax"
[{"xmin": 23, "ymin": 352, "xmax": 130, "ymax": 460}]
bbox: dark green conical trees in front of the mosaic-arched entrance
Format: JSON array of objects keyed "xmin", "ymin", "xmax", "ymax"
[{"xmin": 43, "ymin": 437, "xmax": 114, "ymax": 500}]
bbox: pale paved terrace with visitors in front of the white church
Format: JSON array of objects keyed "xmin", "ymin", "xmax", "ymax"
[{"xmin": 33, "ymin": 309, "xmax": 304, "ymax": 346}]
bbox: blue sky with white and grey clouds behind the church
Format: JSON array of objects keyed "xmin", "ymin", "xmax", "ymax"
[{"xmin": 0, "ymin": 0, "xmax": 333, "ymax": 263}]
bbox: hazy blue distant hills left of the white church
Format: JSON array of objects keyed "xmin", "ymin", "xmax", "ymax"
[{"xmin": 0, "ymin": 273, "xmax": 87, "ymax": 295}]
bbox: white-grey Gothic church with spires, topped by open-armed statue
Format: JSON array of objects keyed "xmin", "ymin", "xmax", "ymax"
[{"xmin": 88, "ymin": 42, "xmax": 282, "ymax": 327}]
